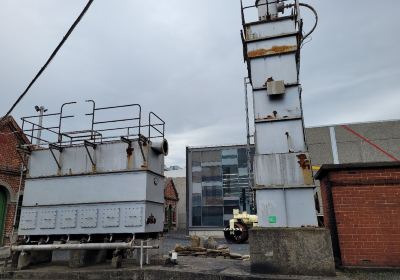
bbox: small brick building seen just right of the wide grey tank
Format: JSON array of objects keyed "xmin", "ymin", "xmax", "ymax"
[{"xmin": 164, "ymin": 178, "xmax": 179, "ymax": 231}]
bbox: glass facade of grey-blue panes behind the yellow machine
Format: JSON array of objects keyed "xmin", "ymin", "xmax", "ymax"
[{"xmin": 187, "ymin": 146, "xmax": 254, "ymax": 227}]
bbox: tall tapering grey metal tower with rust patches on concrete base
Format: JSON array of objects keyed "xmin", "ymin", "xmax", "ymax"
[{"xmin": 242, "ymin": 0, "xmax": 318, "ymax": 227}]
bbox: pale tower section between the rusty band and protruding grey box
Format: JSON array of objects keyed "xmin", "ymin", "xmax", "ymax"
[{"xmin": 250, "ymin": 53, "xmax": 298, "ymax": 88}]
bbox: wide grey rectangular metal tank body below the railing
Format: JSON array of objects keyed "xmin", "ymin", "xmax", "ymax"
[{"xmin": 18, "ymin": 140, "xmax": 164, "ymax": 235}]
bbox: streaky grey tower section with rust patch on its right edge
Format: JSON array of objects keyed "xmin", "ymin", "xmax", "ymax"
[{"xmin": 254, "ymin": 153, "xmax": 313, "ymax": 188}]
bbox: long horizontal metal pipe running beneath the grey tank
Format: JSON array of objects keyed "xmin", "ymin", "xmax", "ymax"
[{"xmin": 11, "ymin": 242, "xmax": 159, "ymax": 252}]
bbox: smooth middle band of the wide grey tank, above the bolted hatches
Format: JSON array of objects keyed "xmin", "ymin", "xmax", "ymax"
[{"xmin": 23, "ymin": 171, "xmax": 164, "ymax": 206}]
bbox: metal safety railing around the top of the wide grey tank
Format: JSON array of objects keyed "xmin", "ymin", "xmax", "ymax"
[{"xmin": 21, "ymin": 100, "xmax": 165, "ymax": 148}]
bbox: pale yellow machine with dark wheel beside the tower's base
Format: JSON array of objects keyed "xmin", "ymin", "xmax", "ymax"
[{"xmin": 224, "ymin": 209, "xmax": 258, "ymax": 244}]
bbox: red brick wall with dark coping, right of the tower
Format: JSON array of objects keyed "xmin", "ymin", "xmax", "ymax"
[{"xmin": 321, "ymin": 168, "xmax": 400, "ymax": 267}]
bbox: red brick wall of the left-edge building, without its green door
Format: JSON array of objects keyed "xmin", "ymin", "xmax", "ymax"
[{"xmin": 0, "ymin": 118, "xmax": 24, "ymax": 244}]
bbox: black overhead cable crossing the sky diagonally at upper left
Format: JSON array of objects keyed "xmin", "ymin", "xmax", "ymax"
[{"xmin": 0, "ymin": 0, "xmax": 93, "ymax": 122}]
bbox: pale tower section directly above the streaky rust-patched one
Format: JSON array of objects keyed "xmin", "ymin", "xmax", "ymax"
[{"xmin": 255, "ymin": 119, "xmax": 306, "ymax": 155}]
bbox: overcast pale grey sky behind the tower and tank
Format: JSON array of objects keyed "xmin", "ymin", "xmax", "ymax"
[{"xmin": 0, "ymin": 0, "xmax": 400, "ymax": 166}]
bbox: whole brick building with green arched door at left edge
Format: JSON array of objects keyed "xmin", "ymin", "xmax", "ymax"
[{"xmin": 0, "ymin": 116, "xmax": 29, "ymax": 245}]
